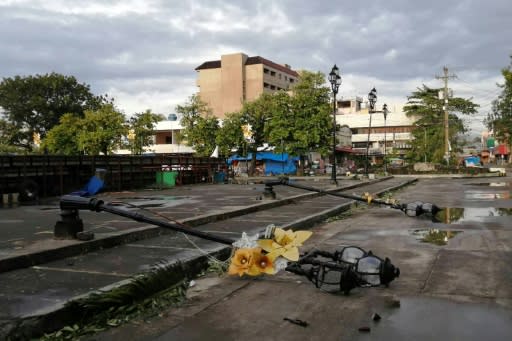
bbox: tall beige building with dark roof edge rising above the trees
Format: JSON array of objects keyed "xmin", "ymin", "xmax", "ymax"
[{"xmin": 196, "ymin": 53, "xmax": 299, "ymax": 119}]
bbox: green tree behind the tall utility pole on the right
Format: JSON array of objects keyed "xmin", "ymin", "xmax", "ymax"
[{"xmin": 403, "ymin": 85, "xmax": 478, "ymax": 163}]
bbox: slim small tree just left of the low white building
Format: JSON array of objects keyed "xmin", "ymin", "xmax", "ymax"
[{"xmin": 128, "ymin": 110, "xmax": 165, "ymax": 155}]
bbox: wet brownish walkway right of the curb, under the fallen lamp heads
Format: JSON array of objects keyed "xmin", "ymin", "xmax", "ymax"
[{"xmin": 87, "ymin": 173, "xmax": 512, "ymax": 341}]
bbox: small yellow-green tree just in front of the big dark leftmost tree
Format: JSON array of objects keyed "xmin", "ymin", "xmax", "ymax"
[{"xmin": 41, "ymin": 114, "xmax": 83, "ymax": 155}]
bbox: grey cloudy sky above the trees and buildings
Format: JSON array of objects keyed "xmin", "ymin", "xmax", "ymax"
[{"xmin": 0, "ymin": 0, "xmax": 512, "ymax": 134}]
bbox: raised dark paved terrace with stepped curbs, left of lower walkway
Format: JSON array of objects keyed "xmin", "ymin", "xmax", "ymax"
[{"xmin": 0, "ymin": 174, "xmax": 411, "ymax": 337}]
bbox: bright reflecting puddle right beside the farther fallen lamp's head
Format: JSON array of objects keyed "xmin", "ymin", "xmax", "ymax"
[{"xmin": 434, "ymin": 207, "xmax": 512, "ymax": 224}]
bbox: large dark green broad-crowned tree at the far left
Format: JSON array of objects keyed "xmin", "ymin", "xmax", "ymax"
[{"xmin": 0, "ymin": 73, "xmax": 106, "ymax": 150}]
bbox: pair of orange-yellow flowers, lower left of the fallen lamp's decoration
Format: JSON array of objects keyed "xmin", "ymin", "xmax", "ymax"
[{"xmin": 228, "ymin": 247, "xmax": 275, "ymax": 276}]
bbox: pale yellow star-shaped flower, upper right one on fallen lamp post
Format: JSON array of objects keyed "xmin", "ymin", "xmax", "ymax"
[{"xmin": 258, "ymin": 227, "xmax": 313, "ymax": 262}]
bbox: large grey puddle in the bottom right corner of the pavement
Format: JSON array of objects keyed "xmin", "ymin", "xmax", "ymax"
[{"xmin": 358, "ymin": 297, "xmax": 512, "ymax": 341}]
